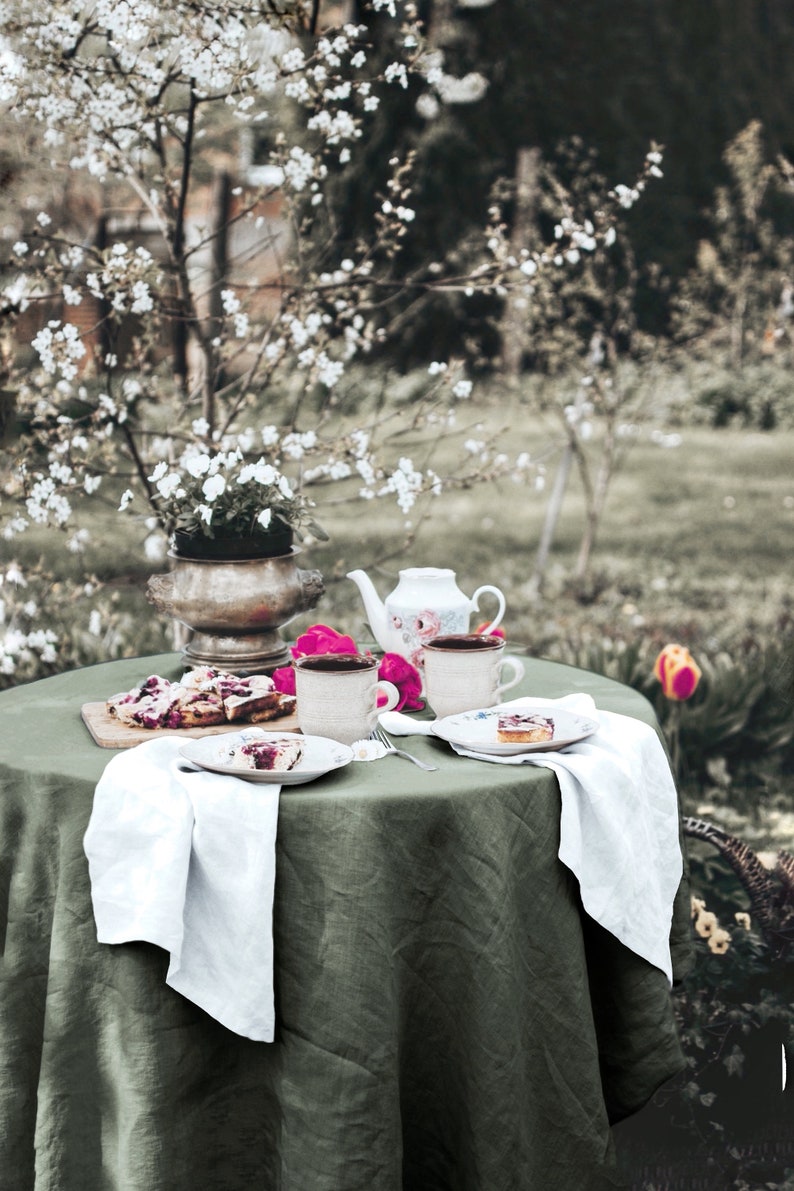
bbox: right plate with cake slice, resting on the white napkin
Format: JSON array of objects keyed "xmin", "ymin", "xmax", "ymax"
[{"xmin": 431, "ymin": 706, "xmax": 599, "ymax": 756}]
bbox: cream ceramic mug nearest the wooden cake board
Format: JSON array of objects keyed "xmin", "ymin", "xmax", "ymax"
[{"xmin": 295, "ymin": 654, "xmax": 400, "ymax": 744}]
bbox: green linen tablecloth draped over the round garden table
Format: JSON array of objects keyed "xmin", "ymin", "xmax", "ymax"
[{"xmin": 0, "ymin": 654, "xmax": 688, "ymax": 1191}]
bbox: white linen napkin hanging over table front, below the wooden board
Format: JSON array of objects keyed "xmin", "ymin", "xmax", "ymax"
[{"xmin": 83, "ymin": 736, "xmax": 281, "ymax": 1042}]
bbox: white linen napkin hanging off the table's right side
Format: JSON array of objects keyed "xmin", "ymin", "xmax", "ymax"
[{"xmin": 454, "ymin": 694, "xmax": 683, "ymax": 983}]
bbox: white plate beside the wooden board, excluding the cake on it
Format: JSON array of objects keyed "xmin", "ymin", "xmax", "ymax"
[{"xmin": 180, "ymin": 728, "xmax": 352, "ymax": 786}]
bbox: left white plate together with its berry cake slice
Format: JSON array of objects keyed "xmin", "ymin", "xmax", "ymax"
[{"xmin": 180, "ymin": 728, "xmax": 354, "ymax": 786}]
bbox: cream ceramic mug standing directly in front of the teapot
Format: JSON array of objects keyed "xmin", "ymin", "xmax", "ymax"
[{"xmin": 425, "ymin": 632, "xmax": 524, "ymax": 719}]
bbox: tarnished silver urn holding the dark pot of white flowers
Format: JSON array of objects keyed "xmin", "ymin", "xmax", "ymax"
[{"xmin": 146, "ymin": 547, "xmax": 325, "ymax": 674}]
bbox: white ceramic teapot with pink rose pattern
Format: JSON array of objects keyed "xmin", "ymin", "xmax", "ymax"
[{"xmin": 348, "ymin": 567, "xmax": 505, "ymax": 666}]
